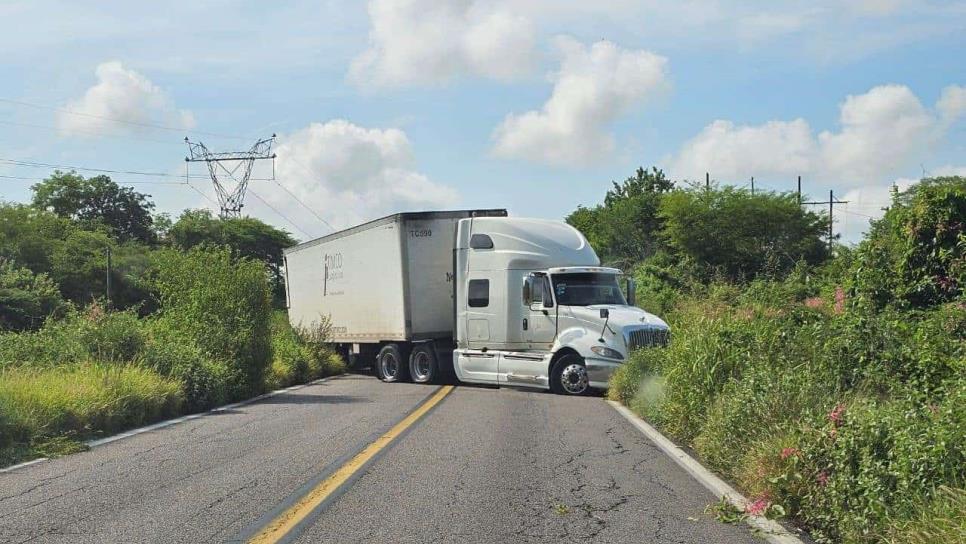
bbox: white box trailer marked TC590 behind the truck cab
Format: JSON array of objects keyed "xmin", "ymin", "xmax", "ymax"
[{"xmin": 284, "ymin": 209, "xmax": 507, "ymax": 372}]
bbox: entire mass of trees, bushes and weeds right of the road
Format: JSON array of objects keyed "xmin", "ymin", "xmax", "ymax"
[{"xmin": 592, "ymin": 170, "xmax": 966, "ymax": 543}]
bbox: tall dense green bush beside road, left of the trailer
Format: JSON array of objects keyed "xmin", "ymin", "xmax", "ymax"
[{"xmin": 152, "ymin": 249, "xmax": 272, "ymax": 400}]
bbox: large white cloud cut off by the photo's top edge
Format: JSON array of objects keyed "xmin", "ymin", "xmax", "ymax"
[{"xmin": 349, "ymin": 0, "xmax": 535, "ymax": 87}]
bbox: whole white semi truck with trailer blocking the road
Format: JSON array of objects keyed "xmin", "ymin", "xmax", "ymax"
[{"xmin": 283, "ymin": 209, "xmax": 670, "ymax": 395}]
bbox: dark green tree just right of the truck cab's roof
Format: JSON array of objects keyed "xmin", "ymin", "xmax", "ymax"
[{"xmin": 567, "ymin": 167, "xmax": 674, "ymax": 267}]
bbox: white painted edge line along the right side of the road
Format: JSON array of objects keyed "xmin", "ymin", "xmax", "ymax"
[{"xmin": 607, "ymin": 400, "xmax": 804, "ymax": 544}]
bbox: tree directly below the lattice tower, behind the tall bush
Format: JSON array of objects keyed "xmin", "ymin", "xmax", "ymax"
[{"xmin": 168, "ymin": 210, "xmax": 296, "ymax": 296}]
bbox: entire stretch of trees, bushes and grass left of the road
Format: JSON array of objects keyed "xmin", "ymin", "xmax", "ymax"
[{"xmin": 0, "ymin": 172, "xmax": 344, "ymax": 466}]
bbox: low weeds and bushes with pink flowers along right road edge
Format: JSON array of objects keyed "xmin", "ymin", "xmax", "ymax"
[{"xmin": 609, "ymin": 292, "xmax": 966, "ymax": 542}]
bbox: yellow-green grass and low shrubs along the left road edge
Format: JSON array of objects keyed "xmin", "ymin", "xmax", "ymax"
[{"xmin": 0, "ymin": 306, "xmax": 345, "ymax": 466}]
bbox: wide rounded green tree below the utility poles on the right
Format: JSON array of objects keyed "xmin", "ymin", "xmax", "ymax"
[{"xmin": 658, "ymin": 187, "xmax": 828, "ymax": 280}]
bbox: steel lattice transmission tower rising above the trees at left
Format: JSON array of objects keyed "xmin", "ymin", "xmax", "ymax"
[{"xmin": 184, "ymin": 134, "xmax": 275, "ymax": 219}]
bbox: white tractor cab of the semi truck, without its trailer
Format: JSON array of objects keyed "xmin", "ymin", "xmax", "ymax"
[{"xmin": 453, "ymin": 217, "xmax": 669, "ymax": 395}]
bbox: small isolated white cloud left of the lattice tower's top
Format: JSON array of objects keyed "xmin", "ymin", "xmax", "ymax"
[{"xmin": 57, "ymin": 61, "xmax": 195, "ymax": 136}]
